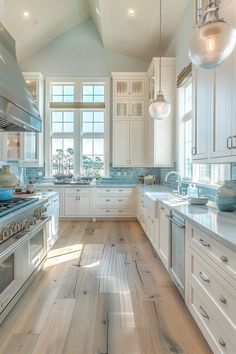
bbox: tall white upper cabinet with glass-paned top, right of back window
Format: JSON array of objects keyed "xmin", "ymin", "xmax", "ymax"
[{"xmin": 112, "ymin": 73, "xmax": 146, "ymax": 167}]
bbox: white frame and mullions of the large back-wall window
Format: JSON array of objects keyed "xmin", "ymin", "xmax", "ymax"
[{"xmin": 45, "ymin": 76, "xmax": 110, "ymax": 177}]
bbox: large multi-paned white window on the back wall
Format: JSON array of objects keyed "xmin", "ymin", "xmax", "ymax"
[{"xmin": 46, "ymin": 78, "xmax": 110, "ymax": 176}]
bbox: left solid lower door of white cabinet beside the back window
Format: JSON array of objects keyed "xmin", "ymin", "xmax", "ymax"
[{"xmin": 113, "ymin": 120, "xmax": 130, "ymax": 166}]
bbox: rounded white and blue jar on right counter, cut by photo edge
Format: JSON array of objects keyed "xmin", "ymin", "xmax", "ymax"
[{"xmin": 216, "ymin": 180, "xmax": 236, "ymax": 211}]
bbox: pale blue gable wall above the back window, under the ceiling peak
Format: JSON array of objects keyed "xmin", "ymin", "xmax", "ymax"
[{"xmin": 20, "ymin": 20, "xmax": 149, "ymax": 76}]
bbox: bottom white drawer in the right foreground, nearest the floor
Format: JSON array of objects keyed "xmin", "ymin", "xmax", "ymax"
[{"xmin": 189, "ymin": 286, "xmax": 236, "ymax": 354}]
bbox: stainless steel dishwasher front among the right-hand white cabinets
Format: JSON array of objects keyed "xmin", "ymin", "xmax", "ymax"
[{"xmin": 167, "ymin": 210, "xmax": 185, "ymax": 298}]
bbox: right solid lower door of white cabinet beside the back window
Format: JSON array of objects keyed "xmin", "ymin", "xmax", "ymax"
[{"xmin": 129, "ymin": 120, "xmax": 145, "ymax": 166}]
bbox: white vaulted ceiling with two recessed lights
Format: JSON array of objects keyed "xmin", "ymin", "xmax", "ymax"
[{"xmin": 0, "ymin": 0, "xmax": 192, "ymax": 61}]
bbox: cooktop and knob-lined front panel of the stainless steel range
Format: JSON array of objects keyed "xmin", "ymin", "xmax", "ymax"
[{"xmin": 0, "ymin": 198, "xmax": 46, "ymax": 244}]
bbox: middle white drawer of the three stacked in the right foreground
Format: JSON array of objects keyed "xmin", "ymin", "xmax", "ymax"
[{"xmin": 189, "ymin": 248, "xmax": 236, "ymax": 329}]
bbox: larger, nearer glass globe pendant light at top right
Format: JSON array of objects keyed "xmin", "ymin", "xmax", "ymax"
[{"xmin": 189, "ymin": 1, "xmax": 236, "ymax": 69}]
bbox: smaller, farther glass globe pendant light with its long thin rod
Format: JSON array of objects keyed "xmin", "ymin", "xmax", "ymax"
[{"xmin": 149, "ymin": 0, "xmax": 171, "ymax": 120}]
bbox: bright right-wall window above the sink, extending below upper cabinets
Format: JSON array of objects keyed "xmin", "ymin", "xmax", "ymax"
[{"xmin": 179, "ymin": 78, "xmax": 231, "ymax": 185}]
